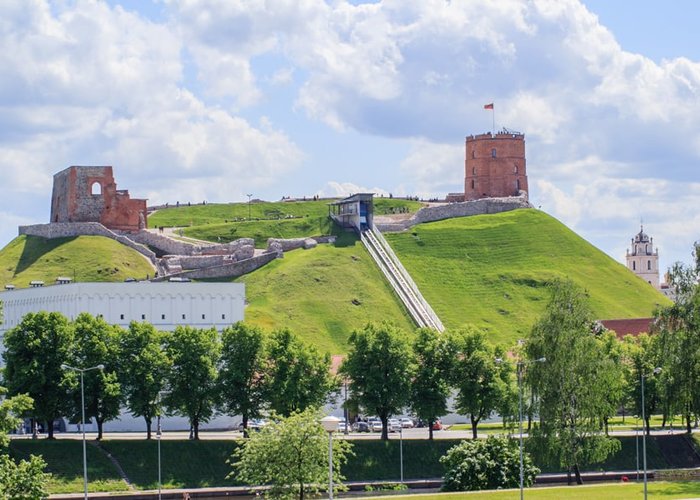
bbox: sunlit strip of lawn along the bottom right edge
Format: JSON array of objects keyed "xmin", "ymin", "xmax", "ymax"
[{"xmin": 365, "ymin": 481, "xmax": 700, "ymax": 500}]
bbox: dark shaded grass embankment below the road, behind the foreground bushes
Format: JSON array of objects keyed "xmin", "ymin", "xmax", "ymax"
[{"xmin": 11, "ymin": 437, "xmax": 696, "ymax": 493}]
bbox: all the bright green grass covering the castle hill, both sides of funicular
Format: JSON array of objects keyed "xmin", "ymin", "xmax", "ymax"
[{"xmin": 0, "ymin": 205, "xmax": 668, "ymax": 354}]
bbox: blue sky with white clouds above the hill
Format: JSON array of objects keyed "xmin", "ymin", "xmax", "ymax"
[{"xmin": 0, "ymin": 0, "xmax": 700, "ymax": 273}]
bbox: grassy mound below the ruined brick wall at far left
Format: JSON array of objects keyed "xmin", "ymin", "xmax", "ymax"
[{"xmin": 0, "ymin": 236, "xmax": 154, "ymax": 288}]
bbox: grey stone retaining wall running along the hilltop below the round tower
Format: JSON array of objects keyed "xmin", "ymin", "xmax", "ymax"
[{"xmin": 374, "ymin": 193, "xmax": 532, "ymax": 232}]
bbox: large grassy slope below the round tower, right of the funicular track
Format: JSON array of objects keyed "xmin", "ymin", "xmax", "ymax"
[{"xmin": 385, "ymin": 209, "xmax": 670, "ymax": 342}]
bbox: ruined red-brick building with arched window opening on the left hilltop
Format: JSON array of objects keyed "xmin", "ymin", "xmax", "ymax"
[{"xmin": 51, "ymin": 166, "xmax": 148, "ymax": 231}]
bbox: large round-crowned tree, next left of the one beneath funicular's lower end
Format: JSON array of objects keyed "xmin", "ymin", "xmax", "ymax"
[{"xmin": 341, "ymin": 323, "xmax": 413, "ymax": 440}]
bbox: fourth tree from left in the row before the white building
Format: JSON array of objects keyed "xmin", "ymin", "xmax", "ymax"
[{"xmin": 163, "ymin": 326, "xmax": 221, "ymax": 439}]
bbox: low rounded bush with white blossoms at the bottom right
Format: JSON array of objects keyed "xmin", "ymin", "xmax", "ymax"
[{"xmin": 440, "ymin": 436, "xmax": 540, "ymax": 491}]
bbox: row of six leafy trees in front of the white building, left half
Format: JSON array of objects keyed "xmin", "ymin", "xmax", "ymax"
[{"xmin": 3, "ymin": 312, "xmax": 337, "ymax": 439}]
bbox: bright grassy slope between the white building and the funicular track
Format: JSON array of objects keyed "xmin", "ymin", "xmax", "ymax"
[{"xmin": 226, "ymin": 233, "xmax": 415, "ymax": 354}]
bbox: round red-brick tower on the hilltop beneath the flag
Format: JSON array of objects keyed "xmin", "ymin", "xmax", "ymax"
[{"xmin": 464, "ymin": 130, "xmax": 528, "ymax": 201}]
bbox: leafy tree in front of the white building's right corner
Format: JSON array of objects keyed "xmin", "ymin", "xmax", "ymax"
[{"xmin": 216, "ymin": 323, "xmax": 267, "ymax": 434}]
